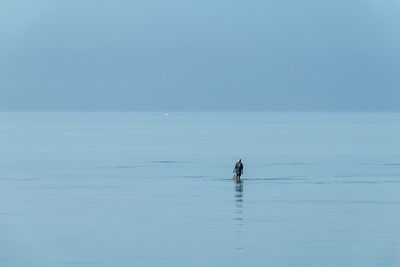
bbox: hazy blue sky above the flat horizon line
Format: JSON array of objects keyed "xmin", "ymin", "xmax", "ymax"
[{"xmin": 0, "ymin": 0, "xmax": 400, "ymax": 111}]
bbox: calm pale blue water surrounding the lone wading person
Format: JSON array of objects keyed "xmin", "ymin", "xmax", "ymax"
[{"xmin": 0, "ymin": 112, "xmax": 400, "ymax": 267}]
